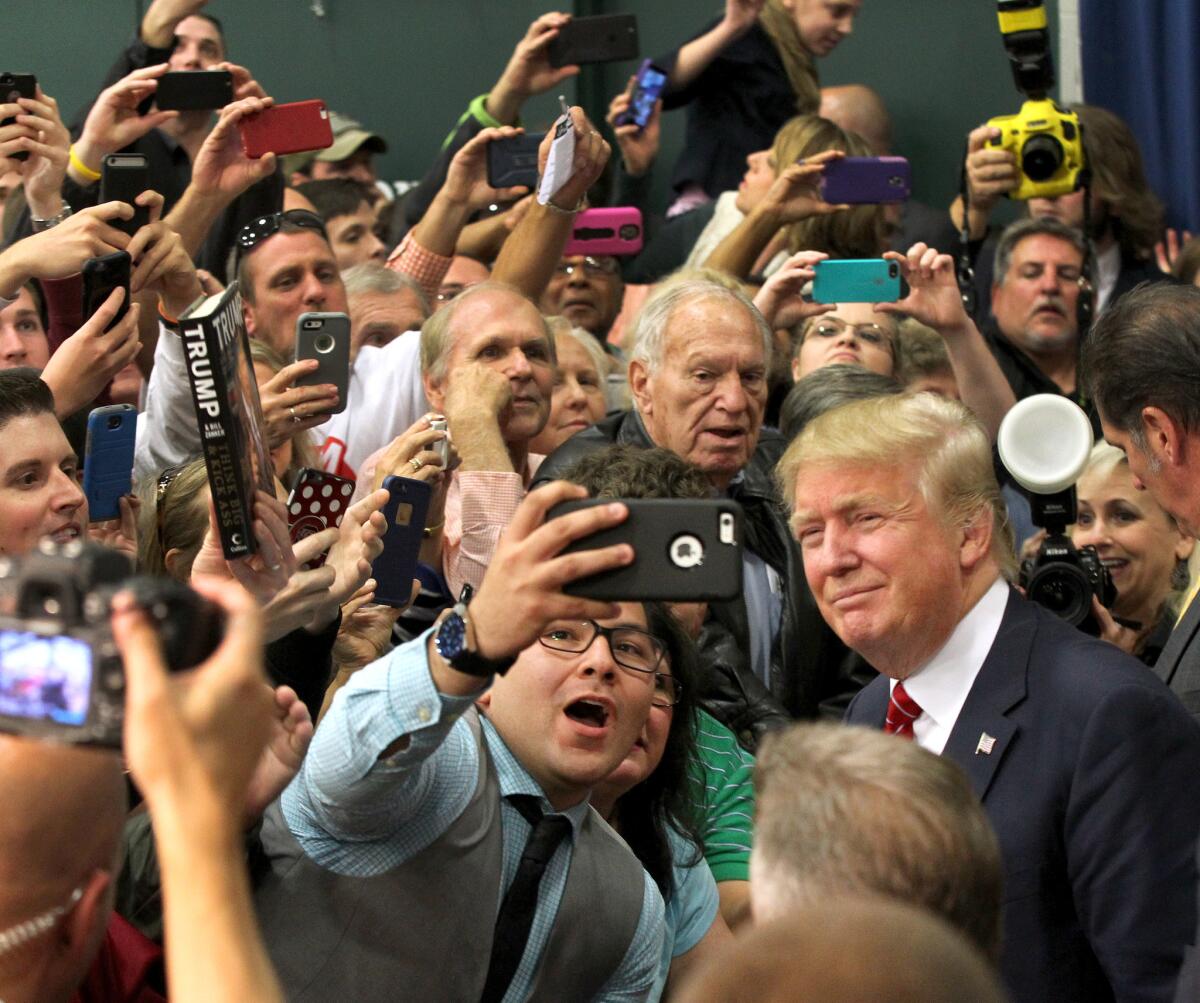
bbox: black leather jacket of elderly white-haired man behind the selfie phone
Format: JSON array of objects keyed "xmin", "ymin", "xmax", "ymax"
[{"xmin": 534, "ymin": 412, "xmax": 874, "ymax": 750}]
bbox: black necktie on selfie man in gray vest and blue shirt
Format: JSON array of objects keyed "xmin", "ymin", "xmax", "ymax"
[{"xmin": 480, "ymin": 794, "xmax": 571, "ymax": 1003}]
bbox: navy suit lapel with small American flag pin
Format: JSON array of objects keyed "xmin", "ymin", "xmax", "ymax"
[{"xmin": 942, "ymin": 591, "xmax": 1037, "ymax": 800}]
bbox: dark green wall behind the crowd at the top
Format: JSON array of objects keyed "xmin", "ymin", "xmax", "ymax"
[{"xmin": 11, "ymin": 0, "xmax": 1055, "ymax": 215}]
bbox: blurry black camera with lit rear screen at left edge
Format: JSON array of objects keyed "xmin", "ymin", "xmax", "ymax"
[{"xmin": 0, "ymin": 540, "xmax": 224, "ymax": 749}]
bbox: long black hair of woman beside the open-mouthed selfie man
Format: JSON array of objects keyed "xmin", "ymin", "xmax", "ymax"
[{"xmin": 616, "ymin": 602, "xmax": 703, "ymax": 899}]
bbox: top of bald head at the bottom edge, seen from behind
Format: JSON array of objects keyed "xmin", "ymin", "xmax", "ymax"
[{"xmin": 678, "ymin": 899, "xmax": 1006, "ymax": 1003}]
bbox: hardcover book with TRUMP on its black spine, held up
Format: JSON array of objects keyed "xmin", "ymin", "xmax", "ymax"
[{"xmin": 179, "ymin": 282, "xmax": 275, "ymax": 559}]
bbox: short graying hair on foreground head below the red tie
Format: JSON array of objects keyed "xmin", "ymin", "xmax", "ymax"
[{"xmin": 750, "ymin": 725, "xmax": 1003, "ymax": 959}]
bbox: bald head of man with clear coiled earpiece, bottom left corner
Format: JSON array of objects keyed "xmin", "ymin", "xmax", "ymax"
[{"xmin": 0, "ymin": 735, "xmax": 125, "ymax": 1003}]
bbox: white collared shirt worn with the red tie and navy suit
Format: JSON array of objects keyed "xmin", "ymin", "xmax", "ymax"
[{"xmin": 892, "ymin": 578, "xmax": 1008, "ymax": 756}]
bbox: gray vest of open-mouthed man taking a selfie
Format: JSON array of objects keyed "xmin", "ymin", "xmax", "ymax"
[{"xmin": 256, "ymin": 709, "xmax": 644, "ymax": 1003}]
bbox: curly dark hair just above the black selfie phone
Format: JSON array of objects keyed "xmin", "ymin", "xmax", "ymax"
[{"xmin": 562, "ymin": 444, "xmax": 713, "ymax": 498}]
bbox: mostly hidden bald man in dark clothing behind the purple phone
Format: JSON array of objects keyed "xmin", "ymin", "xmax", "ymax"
[{"xmin": 818, "ymin": 84, "xmax": 958, "ymax": 254}]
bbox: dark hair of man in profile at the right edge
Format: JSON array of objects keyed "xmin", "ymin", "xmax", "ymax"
[{"xmin": 1080, "ymin": 282, "xmax": 1200, "ymax": 441}]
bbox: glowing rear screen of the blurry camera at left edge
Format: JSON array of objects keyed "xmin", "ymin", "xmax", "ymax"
[{"xmin": 0, "ymin": 630, "xmax": 92, "ymax": 725}]
